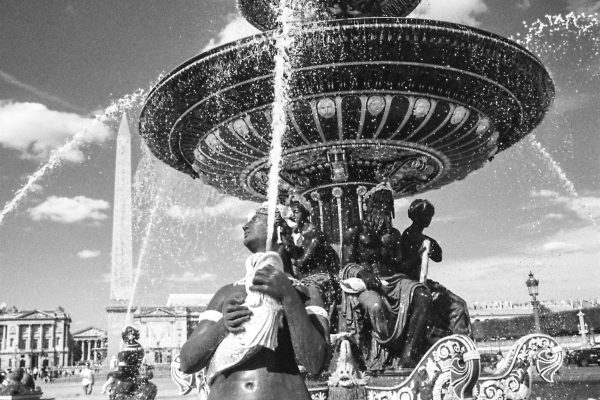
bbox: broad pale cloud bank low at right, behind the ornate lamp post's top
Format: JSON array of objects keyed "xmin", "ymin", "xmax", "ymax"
[{"xmin": 429, "ymin": 236, "xmax": 600, "ymax": 303}]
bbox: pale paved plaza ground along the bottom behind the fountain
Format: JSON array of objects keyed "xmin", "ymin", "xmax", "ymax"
[{"xmin": 39, "ymin": 366, "xmax": 600, "ymax": 400}]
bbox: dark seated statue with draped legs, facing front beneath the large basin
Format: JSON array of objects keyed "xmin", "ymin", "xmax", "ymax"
[{"xmin": 342, "ymin": 183, "xmax": 431, "ymax": 370}]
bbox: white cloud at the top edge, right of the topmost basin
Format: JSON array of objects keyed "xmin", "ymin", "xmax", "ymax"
[{"xmin": 410, "ymin": 0, "xmax": 488, "ymax": 26}]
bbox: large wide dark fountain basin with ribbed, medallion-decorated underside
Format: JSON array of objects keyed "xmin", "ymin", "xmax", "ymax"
[{"xmin": 140, "ymin": 18, "xmax": 554, "ymax": 200}]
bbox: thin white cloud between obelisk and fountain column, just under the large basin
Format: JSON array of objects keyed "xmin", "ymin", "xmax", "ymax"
[{"xmin": 166, "ymin": 197, "xmax": 256, "ymax": 221}]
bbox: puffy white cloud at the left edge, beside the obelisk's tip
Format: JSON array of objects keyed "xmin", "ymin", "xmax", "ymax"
[{"xmin": 0, "ymin": 101, "xmax": 113, "ymax": 162}]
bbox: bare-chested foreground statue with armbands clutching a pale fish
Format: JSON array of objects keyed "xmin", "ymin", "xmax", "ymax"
[{"xmin": 180, "ymin": 207, "xmax": 329, "ymax": 400}]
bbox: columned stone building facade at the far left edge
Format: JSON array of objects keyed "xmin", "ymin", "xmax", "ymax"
[{"xmin": 0, "ymin": 307, "xmax": 71, "ymax": 369}]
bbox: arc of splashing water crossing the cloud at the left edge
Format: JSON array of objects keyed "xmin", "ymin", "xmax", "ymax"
[{"xmin": 0, "ymin": 89, "xmax": 146, "ymax": 225}]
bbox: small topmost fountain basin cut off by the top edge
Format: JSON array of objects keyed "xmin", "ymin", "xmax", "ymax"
[{"xmin": 237, "ymin": 0, "xmax": 421, "ymax": 31}]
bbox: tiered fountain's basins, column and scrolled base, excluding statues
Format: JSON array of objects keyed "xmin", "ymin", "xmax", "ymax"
[{"xmin": 140, "ymin": 0, "xmax": 562, "ymax": 399}]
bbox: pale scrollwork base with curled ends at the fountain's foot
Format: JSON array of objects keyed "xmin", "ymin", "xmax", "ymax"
[{"xmin": 171, "ymin": 334, "xmax": 564, "ymax": 400}]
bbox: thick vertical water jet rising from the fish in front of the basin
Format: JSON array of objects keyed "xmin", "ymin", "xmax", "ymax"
[{"xmin": 267, "ymin": 0, "xmax": 294, "ymax": 250}]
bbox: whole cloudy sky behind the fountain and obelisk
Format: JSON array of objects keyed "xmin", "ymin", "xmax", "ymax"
[{"xmin": 0, "ymin": 0, "xmax": 600, "ymax": 329}]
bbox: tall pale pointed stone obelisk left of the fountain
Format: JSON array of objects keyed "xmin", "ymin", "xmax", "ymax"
[{"xmin": 106, "ymin": 113, "xmax": 133, "ymax": 360}]
